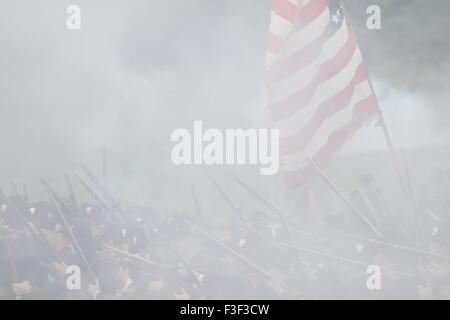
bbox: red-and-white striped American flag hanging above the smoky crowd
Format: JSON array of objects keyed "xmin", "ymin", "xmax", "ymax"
[{"xmin": 266, "ymin": 0, "xmax": 377, "ymax": 188}]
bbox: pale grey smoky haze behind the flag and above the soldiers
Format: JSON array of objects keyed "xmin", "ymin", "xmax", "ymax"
[{"xmin": 0, "ymin": 0, "xmax": 450, "ymax": 212}]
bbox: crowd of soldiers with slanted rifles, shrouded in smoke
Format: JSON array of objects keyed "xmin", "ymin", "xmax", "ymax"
[{"xmin": 0, "ymin": 167, "xmax": 450, "ymax": 299}]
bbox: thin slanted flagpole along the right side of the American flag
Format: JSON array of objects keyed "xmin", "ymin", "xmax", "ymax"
[{"xmin": 339, "ymin": 0, "xmax": 409, "ymax": 202}]
